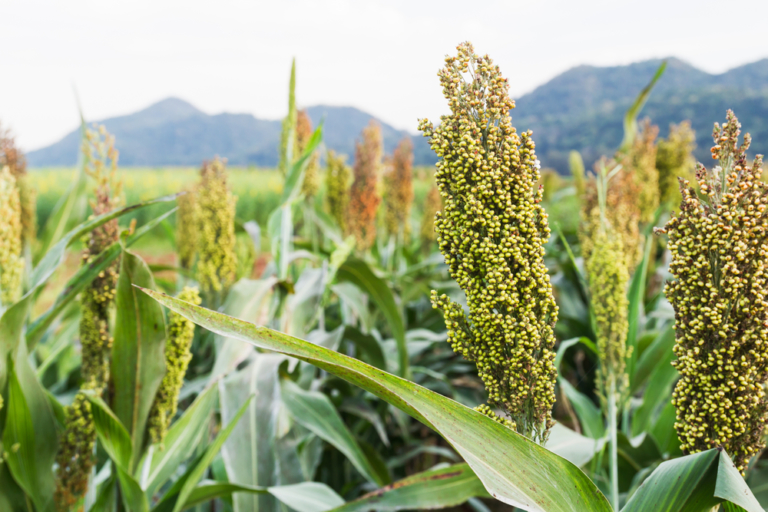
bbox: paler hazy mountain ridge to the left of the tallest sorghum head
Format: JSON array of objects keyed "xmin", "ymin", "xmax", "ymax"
[{"xmin": 27, "ymin": 98, "xmax": 434, "ymax": 167}]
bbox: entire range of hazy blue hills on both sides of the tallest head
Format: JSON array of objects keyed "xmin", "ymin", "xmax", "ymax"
[{"xmin": 27, "ymin": 58, "xmax": 768, "ymax": 173}]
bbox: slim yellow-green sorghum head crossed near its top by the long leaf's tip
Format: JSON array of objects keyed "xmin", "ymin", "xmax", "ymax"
[{"xmin": 147, "ymin": 287, "xmax": 201, "ymax": 443}]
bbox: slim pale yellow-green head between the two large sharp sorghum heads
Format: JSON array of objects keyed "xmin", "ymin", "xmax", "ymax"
[{"xmin": 584, "ymin": 218, "xmax": 629, "ymax": 397}]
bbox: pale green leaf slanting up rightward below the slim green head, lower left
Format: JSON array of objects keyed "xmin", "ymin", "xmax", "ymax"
[{"xmin": 139, "ymin": 386, "xmax": 216, "ymax": 496}]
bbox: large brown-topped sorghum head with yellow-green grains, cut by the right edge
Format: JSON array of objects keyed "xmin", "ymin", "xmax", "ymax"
[{"xmin": 661, "ymin": 110, "xmax": 768, "ymax": 471}]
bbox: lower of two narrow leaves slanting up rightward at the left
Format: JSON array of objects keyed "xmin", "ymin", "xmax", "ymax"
[{"xmin": 27, "ymin": 208, "xmax": 176, "ymax": 350}]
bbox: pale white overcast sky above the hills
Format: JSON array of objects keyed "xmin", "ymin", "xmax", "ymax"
[{"xmin": 0, "ymin": 0, "xmax": 768, "ymax": 151}]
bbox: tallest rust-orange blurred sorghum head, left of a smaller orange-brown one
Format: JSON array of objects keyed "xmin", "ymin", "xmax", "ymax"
[{"xmin": 347, "ymin": 120, "xmax": 384, "ymax": 250}]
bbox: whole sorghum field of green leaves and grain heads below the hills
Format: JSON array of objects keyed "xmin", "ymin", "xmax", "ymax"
[{"xmin": 0, "ymin": 43, "xmax": 768, "ymax": 512}]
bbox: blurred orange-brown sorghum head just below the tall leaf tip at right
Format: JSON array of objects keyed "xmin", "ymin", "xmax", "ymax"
[{"xmin": 622, "ymin": 119, "xmax": 659, "ymax": 222}]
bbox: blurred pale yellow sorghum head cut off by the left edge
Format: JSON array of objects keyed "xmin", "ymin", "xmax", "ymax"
[{"xmin": 0, "ymin": 166, "xmax": 24, "ymax": 311}]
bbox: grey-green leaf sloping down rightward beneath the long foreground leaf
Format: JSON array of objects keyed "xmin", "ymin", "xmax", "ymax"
[{"xmin": 280, "ymin": 379, "xmax": 389, "ymax": 486}]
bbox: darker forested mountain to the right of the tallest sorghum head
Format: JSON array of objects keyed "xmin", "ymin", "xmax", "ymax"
[{"xmin": 512, "ymin": 58, "xmax": 768, "ymax": 173}]
